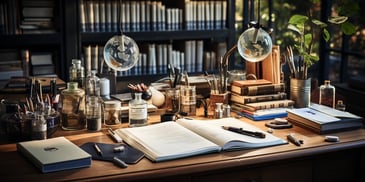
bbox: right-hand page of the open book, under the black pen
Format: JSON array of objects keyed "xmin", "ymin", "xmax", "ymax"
[{"xmin": 176, "ymin": 118, "xmax": 286, "ymax": 150}]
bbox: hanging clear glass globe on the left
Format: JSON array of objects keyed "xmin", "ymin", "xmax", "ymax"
[{"xmin": 104, "ymin": 35, "xmax": 139, "ymax": 71}]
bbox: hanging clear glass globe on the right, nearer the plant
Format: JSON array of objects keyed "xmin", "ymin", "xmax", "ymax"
[{"xmin": 237, "ymin": 27, "xmax": 272, "ymax": 62}]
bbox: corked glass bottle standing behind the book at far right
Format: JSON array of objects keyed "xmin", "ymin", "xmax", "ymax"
[{"xmin": 319, "ymin": 80, "xmax": 335, "ymax": 108}]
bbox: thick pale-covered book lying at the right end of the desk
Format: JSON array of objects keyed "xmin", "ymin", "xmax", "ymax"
[{"xmin": 288, "ymin": 103, "xmax": 363, "ymax": 134}]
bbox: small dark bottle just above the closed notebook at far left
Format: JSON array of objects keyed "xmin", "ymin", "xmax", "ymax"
[{"xmin": 31, "ymin": 112, "xmax": 47, "ymax": 140}]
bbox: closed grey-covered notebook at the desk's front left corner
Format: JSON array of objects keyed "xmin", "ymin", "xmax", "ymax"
[{"xmin": 16, "ymin": 137, "xmax": 91, "ymax": 173}]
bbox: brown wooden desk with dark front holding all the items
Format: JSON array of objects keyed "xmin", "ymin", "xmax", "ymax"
[{"xmin": 0, "ymin": 110, "xmax": 365, "ymax": 182}]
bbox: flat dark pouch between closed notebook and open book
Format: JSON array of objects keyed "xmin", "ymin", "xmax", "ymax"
[{"xmin": 80, "ymin": 142, "xmax": 144, "ymax": 164}]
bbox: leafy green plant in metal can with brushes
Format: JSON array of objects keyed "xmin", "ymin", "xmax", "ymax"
[{"xmin": 287, "ymin": 0, "xmax": 356, "ymax": 107}]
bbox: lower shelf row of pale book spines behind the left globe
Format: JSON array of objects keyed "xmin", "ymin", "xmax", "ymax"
[{"xmin": 83, "ymin": 40, "xmax": 227, "ymax": 76}]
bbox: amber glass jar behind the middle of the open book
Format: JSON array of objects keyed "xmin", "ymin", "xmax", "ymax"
[{"xmin": 180, "ymin": 86, "xmax": 196, "ymax": 116}]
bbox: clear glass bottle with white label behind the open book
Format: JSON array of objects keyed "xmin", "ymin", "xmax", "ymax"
[{"xmin": 129, "ymin": 92, "xmax": 147, "ymax": 127}]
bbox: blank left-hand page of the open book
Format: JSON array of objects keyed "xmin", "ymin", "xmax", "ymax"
[{"xmin": 115, "ymin": 121, "xmax": 221, "ymax": 161}]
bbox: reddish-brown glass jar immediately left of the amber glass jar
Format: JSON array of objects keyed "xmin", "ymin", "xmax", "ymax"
[{"xmin": 165, "ymin": 88, "xmax": 180, "ymax": 113}]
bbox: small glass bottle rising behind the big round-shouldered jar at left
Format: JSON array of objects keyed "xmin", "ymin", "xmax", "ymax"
[{"xmin": 69, "ymin": 59, "xmax": 85, "ymax": 88}]
